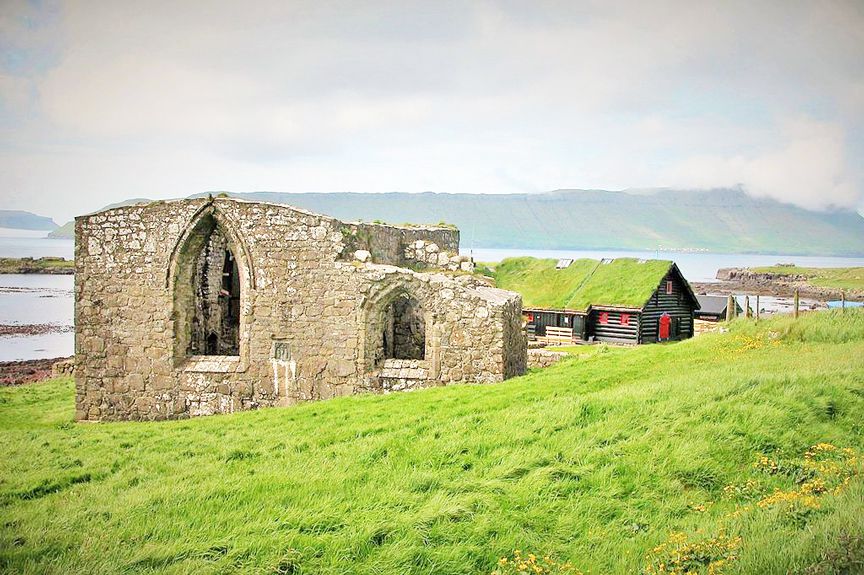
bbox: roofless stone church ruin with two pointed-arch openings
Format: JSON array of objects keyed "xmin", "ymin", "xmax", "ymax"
[{"xmin": 75, "ymin": 197, "xmax": 527, "ymax": 420}]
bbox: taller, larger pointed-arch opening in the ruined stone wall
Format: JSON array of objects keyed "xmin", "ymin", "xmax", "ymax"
[{"xmin": 174, "ymin": 213, "xmax": 242, "ymax": 359}]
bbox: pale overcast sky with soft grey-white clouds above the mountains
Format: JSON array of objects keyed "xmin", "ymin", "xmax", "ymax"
[{"xmin": 0, "ymin": 0, "xmax": 864, "ymax": 223}]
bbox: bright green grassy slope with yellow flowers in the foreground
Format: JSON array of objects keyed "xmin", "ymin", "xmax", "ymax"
[{"xmin": 0, "ymin": 310, "xmax": 864, "ymax": 574}]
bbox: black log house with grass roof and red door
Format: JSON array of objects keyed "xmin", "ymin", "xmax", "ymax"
[{"xmin": 495, "ymin": 258, "xmax": 699, "ymax": 344}]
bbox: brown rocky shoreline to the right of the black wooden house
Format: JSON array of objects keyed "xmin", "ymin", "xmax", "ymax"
[{"xmin": 690, "ymin": 268, "xmax": 864, "ymax": 302}]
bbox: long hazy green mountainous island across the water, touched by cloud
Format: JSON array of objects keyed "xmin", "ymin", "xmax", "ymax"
[{"xmin": 15, "ymin": 189, "xmax": 864, "ymax": 256}]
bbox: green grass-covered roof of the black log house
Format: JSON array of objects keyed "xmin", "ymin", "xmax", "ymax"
[{"xmin": 495, "ymin": 257, "xmax": 672, "ymax": 310}]
